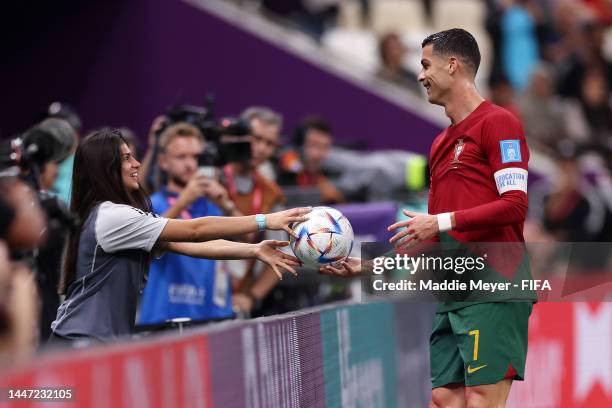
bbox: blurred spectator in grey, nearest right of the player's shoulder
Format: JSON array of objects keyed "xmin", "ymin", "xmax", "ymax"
[{"xmin": 519, "ymin": 63, "xmax": 566, "ymax": 153}]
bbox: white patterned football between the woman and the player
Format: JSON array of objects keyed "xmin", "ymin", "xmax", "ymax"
[{"xmin": 290, "ymin": 207, "xmax": 354, "ymax": 269}]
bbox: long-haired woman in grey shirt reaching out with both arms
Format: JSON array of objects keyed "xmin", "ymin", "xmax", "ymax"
[{"xmin": 51, "ymin": 130, "xmax": 310, "ymax": 342}]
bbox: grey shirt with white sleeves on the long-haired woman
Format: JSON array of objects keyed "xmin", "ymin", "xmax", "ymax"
[{"xmin": 51, "ymin": 201, "xmax": 168, "ymax": 341}]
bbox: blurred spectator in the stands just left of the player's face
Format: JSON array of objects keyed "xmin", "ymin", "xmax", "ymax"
[{"xmin": 376, "ymin": 33, "xmax": 422, "ymax": 94}]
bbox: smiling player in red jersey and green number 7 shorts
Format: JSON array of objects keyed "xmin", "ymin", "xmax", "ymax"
[{"xmin": 321, "ymin": 29, "xmax": 532, "ymax": 408}]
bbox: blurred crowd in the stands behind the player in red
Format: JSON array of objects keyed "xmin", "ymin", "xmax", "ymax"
[{"xmin": 262, "ymin": 0, "xmax": 612, "ymax": 242}]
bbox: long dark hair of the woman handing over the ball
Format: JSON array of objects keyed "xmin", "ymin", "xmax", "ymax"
[{"xmin": 59, "ymin": 129, "xmax": 151, "ymax": 295}]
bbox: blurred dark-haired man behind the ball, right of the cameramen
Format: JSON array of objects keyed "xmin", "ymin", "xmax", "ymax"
[{"xmin": 279, "ymin": 117, "xmax": 344, "ymax": 204}]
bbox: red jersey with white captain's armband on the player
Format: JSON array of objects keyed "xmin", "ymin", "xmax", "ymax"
[{"xmin": 429, "ymin": 101, "xmax": 529, "ymax": 242}]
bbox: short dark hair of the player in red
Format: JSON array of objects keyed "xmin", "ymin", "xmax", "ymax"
[{"xmin": 421, "ymin": 28, "xmax": 480, "ymax": 75}]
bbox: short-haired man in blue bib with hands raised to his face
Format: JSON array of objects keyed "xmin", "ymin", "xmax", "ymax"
[{"xmin": 139, "ymin": 123, "xmax": 235, "ymax": 325}]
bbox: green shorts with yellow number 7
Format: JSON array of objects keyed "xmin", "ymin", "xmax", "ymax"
[{"xmin": 429, "ymin": 302, "xmax": 533, "ymax": 388}]
